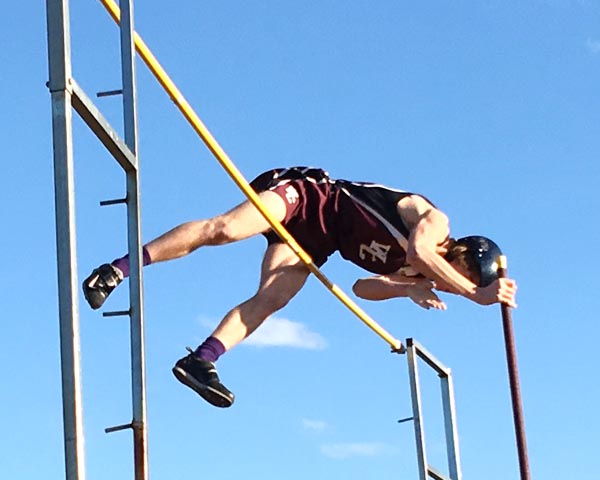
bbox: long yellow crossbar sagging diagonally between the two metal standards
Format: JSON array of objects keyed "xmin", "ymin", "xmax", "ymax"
[{"xmin": 100, "ymin": 0, "xmax": 404, "ymax": 353}]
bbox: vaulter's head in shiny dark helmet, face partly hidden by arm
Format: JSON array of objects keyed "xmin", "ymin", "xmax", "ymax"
[{"xmin": 444, "ymin": 235, "xmax": 502, "ymax": 287}]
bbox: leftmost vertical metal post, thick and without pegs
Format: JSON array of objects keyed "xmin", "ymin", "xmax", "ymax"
[{"xmin": 46, "ymin": 0, "xmax": 85, "ymax": 480}]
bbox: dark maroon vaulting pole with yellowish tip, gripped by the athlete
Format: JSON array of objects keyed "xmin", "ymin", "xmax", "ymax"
[{"xmin": 498, "ymin": 255, "xmax": 531, "ymax": 480}]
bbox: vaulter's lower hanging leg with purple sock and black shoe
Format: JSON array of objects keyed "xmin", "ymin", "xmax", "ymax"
[{"xmin": 173, "ymin": 243, "xmax": 309, "ymax": 407}]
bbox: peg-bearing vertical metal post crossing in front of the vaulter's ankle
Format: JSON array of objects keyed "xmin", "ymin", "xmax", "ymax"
[{"xmin": 120, "ymin": 0, "xmax": 148, "ymax": 480}]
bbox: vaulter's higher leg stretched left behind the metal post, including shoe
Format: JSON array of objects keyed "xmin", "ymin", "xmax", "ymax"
[{"xmin": 83, "ymin": 191, "xmax": 286, "ymax": 309}]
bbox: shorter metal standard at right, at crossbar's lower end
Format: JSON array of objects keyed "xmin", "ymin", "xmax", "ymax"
[{"xmin": 406, "ymin": 338, "xmax": 462, "ymax": 480}]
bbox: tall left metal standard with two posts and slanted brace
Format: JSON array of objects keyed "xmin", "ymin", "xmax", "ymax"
[{"xmin": 46, "ymin": 0, "xmax": 148, "ymax": 480}]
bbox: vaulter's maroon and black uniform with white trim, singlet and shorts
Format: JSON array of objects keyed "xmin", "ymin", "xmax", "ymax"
[{"xmin": 252, "ymin": 167, "xmax": 436, "ymax": 274}]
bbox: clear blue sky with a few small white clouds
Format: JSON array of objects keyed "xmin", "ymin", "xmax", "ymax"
[{"xmin": 0, "ymin": 0, "xmax": 600, "ymax": 480}]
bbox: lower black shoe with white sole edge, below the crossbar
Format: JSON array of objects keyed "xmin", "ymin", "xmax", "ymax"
[{"xmin": 173, "ymin": 350, "xmax": 235, "ymax": 408}]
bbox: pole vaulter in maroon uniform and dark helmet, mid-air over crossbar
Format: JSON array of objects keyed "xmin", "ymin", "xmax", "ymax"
[{"xmin": 83, "ymin": 167, "xmax": 517, "ymax": 407}]
